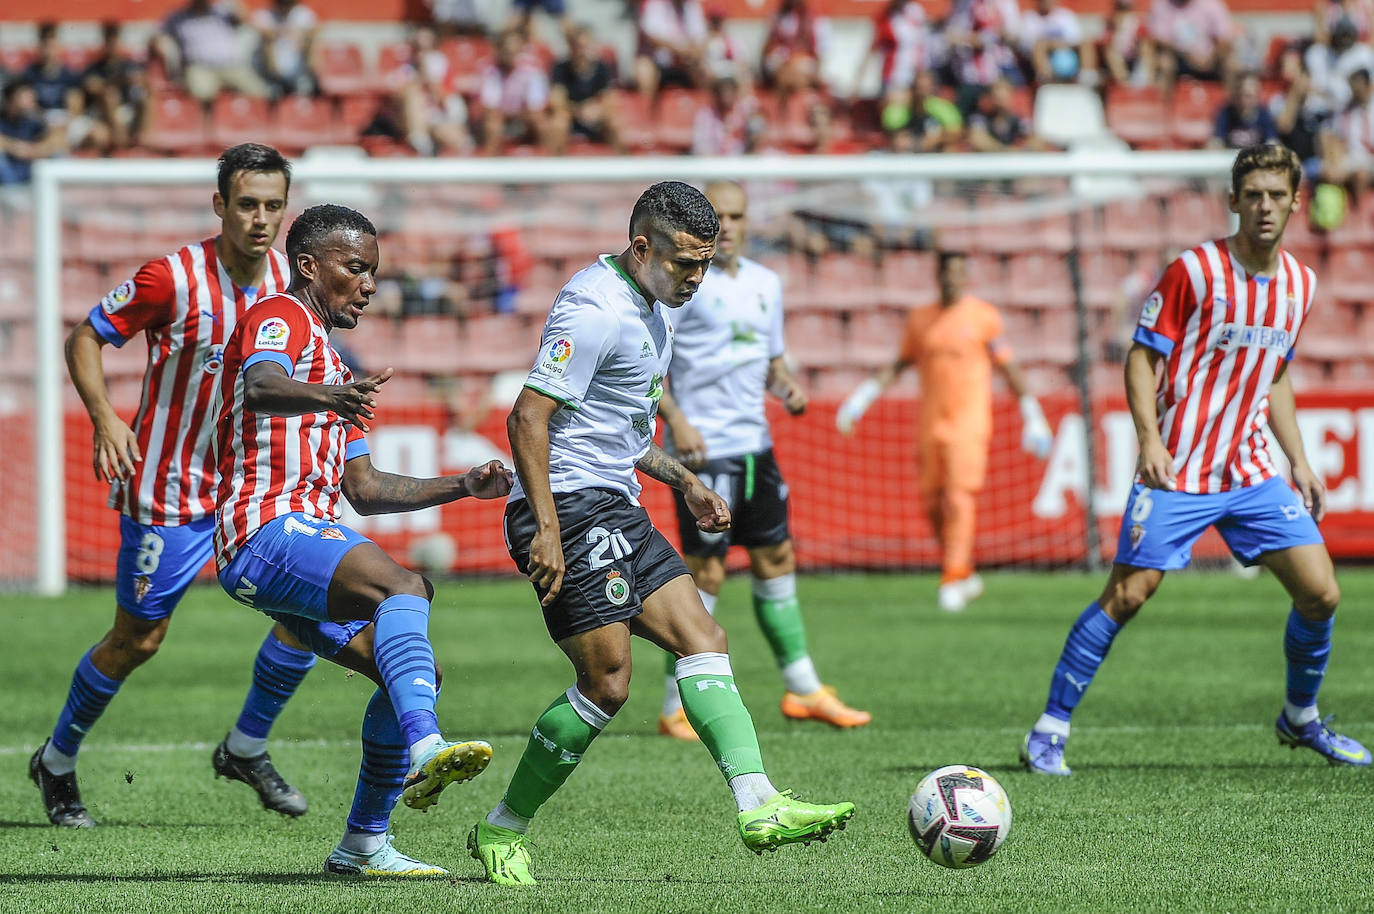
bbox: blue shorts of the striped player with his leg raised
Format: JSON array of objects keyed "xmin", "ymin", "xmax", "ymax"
[{"xmin": 220, "ymin": 514, "xmax": 371, "ymax": 657}]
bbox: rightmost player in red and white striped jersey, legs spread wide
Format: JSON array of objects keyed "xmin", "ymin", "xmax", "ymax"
[{"xmin": 1021, "ymin": 146, "xmax": 1370, "ymax": 775}]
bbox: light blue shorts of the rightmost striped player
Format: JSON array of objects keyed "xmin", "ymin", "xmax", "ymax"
[{"xmin": 1116, "ymin": 477, "xmax": 1323, "ymax": 572}]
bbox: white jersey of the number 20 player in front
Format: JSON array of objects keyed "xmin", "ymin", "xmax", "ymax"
[{"xmin": 510, "ymin": 254, "xmax": 673, "ymax": 504}]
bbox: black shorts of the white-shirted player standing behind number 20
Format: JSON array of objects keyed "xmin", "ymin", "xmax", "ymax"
[{"xmin": 677, "ymin": 448, "xmax": 791, "ymax": 558}]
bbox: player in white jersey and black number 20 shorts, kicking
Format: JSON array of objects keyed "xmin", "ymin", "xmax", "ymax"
[{"xmin": 467, "ymin": 181, "xmax": 853, "ymax": 885}]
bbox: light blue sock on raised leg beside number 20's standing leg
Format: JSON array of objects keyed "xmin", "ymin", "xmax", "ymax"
[{"xmin": 372, "ymin": 594, "xmax": 438, "ymax": 746}]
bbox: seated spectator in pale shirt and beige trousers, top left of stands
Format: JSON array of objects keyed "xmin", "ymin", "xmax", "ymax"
[{"xmin": 154, "ymin": 0, "xmax": 271, "ymax": 104}]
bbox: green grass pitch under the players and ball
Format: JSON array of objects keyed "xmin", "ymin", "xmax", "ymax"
[{"xmin": 0, "ymin": 569, "xmax": 1374, "ymax": 914}]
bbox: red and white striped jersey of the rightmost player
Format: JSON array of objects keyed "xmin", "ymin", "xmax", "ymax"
[{"xmin": 1134, "ymin": 241, "xmax": 1316, "ymax": 493}]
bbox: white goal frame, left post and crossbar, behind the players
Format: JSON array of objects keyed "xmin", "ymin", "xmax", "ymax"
[{"xmin": 29, "ymin": 148, "xmax": 1234, "ymax": 595}]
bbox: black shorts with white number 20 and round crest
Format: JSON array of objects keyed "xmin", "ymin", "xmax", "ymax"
[{"xmin": 506, "ymin": 489, "xmax": 688, "ymax": 640}]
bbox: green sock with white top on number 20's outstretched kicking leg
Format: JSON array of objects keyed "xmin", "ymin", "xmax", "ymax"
[{"xmin": 677, "ymin": 653, "xmax": 764, "ymax": 781}]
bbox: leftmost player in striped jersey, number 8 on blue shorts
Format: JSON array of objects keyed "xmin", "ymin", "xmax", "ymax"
[{"xmin": 29, "ymin": 143, "xmax": 315, "ymax": 827}]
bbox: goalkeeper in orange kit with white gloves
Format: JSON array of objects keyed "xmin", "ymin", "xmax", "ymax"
[{"xmin": 835, "ymin": 250, "xmax": 1054, "ymax": 612}]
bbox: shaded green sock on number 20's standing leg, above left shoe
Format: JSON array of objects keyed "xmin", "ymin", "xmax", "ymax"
[{"xmin": 506, "ymin": 686, "xmax": 610, "ymax": 819}]
